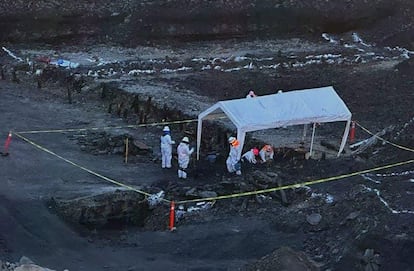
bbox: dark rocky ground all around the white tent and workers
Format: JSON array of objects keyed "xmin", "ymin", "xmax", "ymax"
[{"xmin": 0, "ymin": 1, "xmax": 414, "ymax": 270}]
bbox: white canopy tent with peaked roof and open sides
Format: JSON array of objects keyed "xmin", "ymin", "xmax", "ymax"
[{"xmin": 197, "ymin": 86, "xmax": 352, "ymax": 160}]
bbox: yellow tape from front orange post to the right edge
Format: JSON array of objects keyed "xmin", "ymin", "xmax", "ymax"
[{"xmin": 175, "ymin": 160, "xmax": 414, "ymax": 204}]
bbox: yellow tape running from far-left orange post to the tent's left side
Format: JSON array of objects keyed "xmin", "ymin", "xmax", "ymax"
[{"xmin": 17, "ymin": 119, "xmax": 198, "ymax": 134}]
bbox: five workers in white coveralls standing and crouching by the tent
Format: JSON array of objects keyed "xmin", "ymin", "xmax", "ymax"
[{"xmin": 161, "ymin": 126, "xmax": 274, "ymax": 179}]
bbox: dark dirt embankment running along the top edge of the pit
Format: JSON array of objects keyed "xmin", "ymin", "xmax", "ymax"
[{"xmin": 0, "ymin": 0, "xmax": 414, "ymax": 46}]
